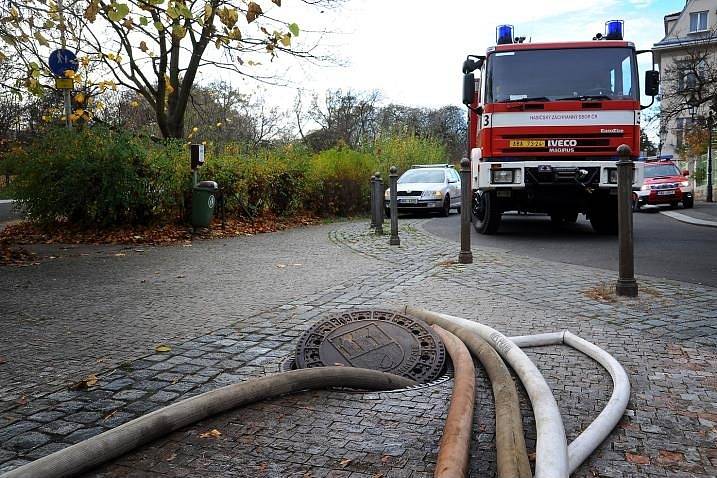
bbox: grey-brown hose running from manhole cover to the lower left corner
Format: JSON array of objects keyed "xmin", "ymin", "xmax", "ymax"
[{"xmin": 2, "ymin": 367, "xmax": 415, "ymax": 478}]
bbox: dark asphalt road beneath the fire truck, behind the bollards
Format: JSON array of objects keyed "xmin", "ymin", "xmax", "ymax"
[{"xmin": 426, "ymin": 209, "xmax": 717, "ymax": 287}]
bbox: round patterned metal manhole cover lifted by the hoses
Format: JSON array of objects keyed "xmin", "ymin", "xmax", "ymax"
[{"xmin": 296, "ymin": 310, "xmax": 446, "ymax": 383}]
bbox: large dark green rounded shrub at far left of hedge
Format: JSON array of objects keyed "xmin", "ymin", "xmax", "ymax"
[{"xmin": 13, "ymin": 127, "xmax": 179, "ymax": 226}]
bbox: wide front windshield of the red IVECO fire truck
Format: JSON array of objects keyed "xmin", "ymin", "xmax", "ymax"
[{"xmin": 486, "ymin": 48, "xmax": 639, "ymax": 103}]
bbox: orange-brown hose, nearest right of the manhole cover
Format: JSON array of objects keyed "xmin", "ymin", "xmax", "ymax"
[{"xmin": 433, "ymin": 325, "xmax": 476, "ymax": 478}]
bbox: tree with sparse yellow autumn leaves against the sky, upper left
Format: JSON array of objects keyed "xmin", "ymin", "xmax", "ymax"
[{"xmin": 0, "ymin": 0, "xmax": 336, "ymax": 138}]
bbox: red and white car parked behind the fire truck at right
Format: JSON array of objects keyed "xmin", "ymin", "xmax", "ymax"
[{"xmin": 632, "ymin": 160, "xmax": 694, "ymax": 211}]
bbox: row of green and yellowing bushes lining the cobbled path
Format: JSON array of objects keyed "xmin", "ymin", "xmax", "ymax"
[{"xmin": 5, "ymin": 127, "xmax": 446, "ymax": 229}]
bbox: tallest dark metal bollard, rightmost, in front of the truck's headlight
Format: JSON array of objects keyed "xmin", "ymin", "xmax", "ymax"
[{"xmin": 615, "ymin": 144, "xmax": 637, "ymax": 297}]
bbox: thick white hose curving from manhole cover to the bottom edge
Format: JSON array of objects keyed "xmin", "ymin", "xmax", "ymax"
[{"xmin": 406, "ymin": 306, "xmax": 568, "ymax": 478}]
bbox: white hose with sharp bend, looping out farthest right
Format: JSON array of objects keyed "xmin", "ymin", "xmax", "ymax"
[{"xmin": 510, "ymin": 330, "xmax": 630, "ymax": 473}]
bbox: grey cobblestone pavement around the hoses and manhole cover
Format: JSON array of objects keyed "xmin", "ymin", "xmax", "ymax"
[{"xmin": 0, "ymin": 220, "xmax": 717, "ymax": 478}]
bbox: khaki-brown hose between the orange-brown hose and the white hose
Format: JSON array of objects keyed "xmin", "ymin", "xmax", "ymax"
[{"xmin": 420, "ymin": 312, "xmax": 533, "ymax": 478}]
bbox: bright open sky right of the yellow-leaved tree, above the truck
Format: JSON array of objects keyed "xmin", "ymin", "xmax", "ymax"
[{"xmin": 221, "ymin": 0, "xmax": 683, "ymax": 106}]
